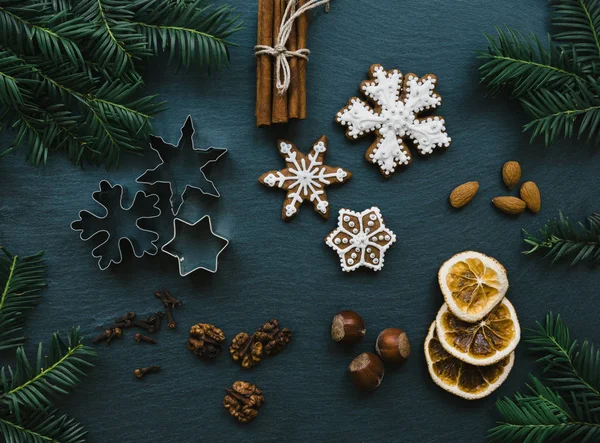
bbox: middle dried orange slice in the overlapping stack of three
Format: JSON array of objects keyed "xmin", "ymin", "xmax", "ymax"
[{"xmin": 435, "ymin": 298, "xmax": 521, "ymax": 366}]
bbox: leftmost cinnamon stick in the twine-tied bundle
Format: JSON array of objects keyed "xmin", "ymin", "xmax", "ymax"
[{"xmin": 255, "ymin": 0, "xmax": 274, "ymax": 126}]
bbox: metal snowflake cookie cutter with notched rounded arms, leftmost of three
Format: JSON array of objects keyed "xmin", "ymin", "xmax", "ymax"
[{"xmin": 71, "ymin": 180, "xmax": 161, "ymax": 271}]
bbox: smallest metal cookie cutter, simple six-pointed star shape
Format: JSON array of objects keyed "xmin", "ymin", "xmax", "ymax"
[{"xmin": 161, "ymin": 215, "xmax": 229, "ymax": 277}]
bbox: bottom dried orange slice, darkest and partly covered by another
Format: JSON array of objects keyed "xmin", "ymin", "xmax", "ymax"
[{"xmin": 425, "ymin": 322, "xmax": 515, "ymax": 400}]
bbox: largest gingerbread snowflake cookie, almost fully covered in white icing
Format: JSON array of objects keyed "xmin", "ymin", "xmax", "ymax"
[{"xmin": 336, "ymin": 65, "xmax": 451, "ymax": 177}]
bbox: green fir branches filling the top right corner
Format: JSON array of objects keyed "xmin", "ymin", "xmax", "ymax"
[{"xmin": 478, "ymin": 0, "xmax": 600, "ymax": 145}]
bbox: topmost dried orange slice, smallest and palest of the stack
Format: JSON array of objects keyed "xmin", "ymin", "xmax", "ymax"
[{"xmin": 438, "ymin": 251, "xmax": 508, "ymax": 322}]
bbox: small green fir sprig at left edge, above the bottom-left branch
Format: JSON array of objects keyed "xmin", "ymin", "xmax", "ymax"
[{"xmin": 0, "ymin": 247, "xmax": 46, "ymax": 351}]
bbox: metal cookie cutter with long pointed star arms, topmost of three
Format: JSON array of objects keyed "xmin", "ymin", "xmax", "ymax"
[{"xmin": 135, "ymin": 115, "xmax": 227, "ymax": 216}]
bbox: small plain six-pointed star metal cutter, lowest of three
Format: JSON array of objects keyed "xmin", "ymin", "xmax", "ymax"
[{"xmin": 161, "ymin": 215, "xmax": 229, "ymax": 277}]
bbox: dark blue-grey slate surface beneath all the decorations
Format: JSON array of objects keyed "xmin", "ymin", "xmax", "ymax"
[{"xmin": 0, "ymin": 0, "xmax": 600, "ymax": 443}]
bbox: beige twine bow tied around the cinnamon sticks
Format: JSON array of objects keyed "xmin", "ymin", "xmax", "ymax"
[{"xmin": 254, "ymin": 0, "xmax": 331, "ymax": 95}]
